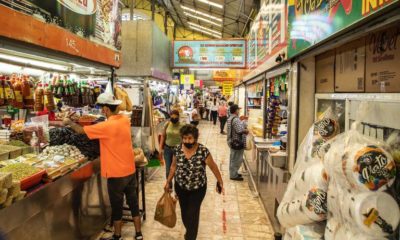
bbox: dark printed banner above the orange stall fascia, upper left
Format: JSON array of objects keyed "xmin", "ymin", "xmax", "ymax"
[{"xmin": 0, "ymin": 0, "xmax": 121, "ymax": 50}]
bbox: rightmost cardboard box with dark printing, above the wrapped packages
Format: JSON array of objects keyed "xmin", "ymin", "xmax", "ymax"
[{"xmin": 366, "ymin": 22, "xmax": 400, "ymax": 93}]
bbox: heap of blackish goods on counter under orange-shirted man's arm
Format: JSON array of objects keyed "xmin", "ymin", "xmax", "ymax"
[{"xmin": 50, "ymin": 127, "xmax": 100, "ymax": 160}]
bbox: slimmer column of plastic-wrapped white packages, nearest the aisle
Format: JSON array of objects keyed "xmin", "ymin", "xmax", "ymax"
[{"xmin": 277, "ymin": 108, "xmax": 340, "ymax": 228}]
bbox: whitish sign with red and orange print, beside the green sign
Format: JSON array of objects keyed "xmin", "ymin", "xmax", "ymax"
[{"xmin": 248, "ymin": 0, "xmax": 287, "ymax": 69}]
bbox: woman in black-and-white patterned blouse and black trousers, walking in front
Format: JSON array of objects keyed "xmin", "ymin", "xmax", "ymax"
[{"xmin": 164, "ymin": 125, "xmax": 224, "ymax": 240}]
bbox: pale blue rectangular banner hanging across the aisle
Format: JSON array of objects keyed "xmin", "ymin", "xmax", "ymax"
[{"xmin": 173, "ymin": 39, "xmax": 246, "ymax": 68}]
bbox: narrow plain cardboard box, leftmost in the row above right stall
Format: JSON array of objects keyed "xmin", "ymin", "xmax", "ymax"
[{"xmin": 315, "ymin": 50, "xmax": 335, "ymax": 93}]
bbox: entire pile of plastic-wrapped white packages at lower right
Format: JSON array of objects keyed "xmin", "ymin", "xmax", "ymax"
[{"xmin": 277, "ymin": 109, "xmax": 400, "ymax": 240}]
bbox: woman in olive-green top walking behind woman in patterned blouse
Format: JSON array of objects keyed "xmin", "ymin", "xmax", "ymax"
[{"xmin": 160, "ymin": 110, "xmax": 184, "ymax": 190}]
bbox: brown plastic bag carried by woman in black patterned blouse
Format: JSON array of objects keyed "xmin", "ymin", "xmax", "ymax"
[{"xmin": 154, "ymin": 192, "xmax": 176, "ymax": 228}]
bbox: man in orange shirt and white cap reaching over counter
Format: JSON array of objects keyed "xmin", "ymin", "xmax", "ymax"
[{"xmin": 64, "ymin": 93, "xmax": 143, "ymax": 240}]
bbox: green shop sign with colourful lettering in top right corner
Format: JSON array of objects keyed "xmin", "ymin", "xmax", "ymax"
[{"xmin": 288, "ymin": 0, "xmax": 398, "ymax": 57}]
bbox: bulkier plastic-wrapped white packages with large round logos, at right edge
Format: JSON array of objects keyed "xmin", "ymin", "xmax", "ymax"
[{"xmin": 324, "ymin": 125, "xmax": 400, "ymax": 240}]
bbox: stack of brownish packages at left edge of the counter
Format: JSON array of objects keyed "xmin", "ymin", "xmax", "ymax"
[{"xmin": 0, "ymin": 172, "xmax": 26, "ymax": 208}]
